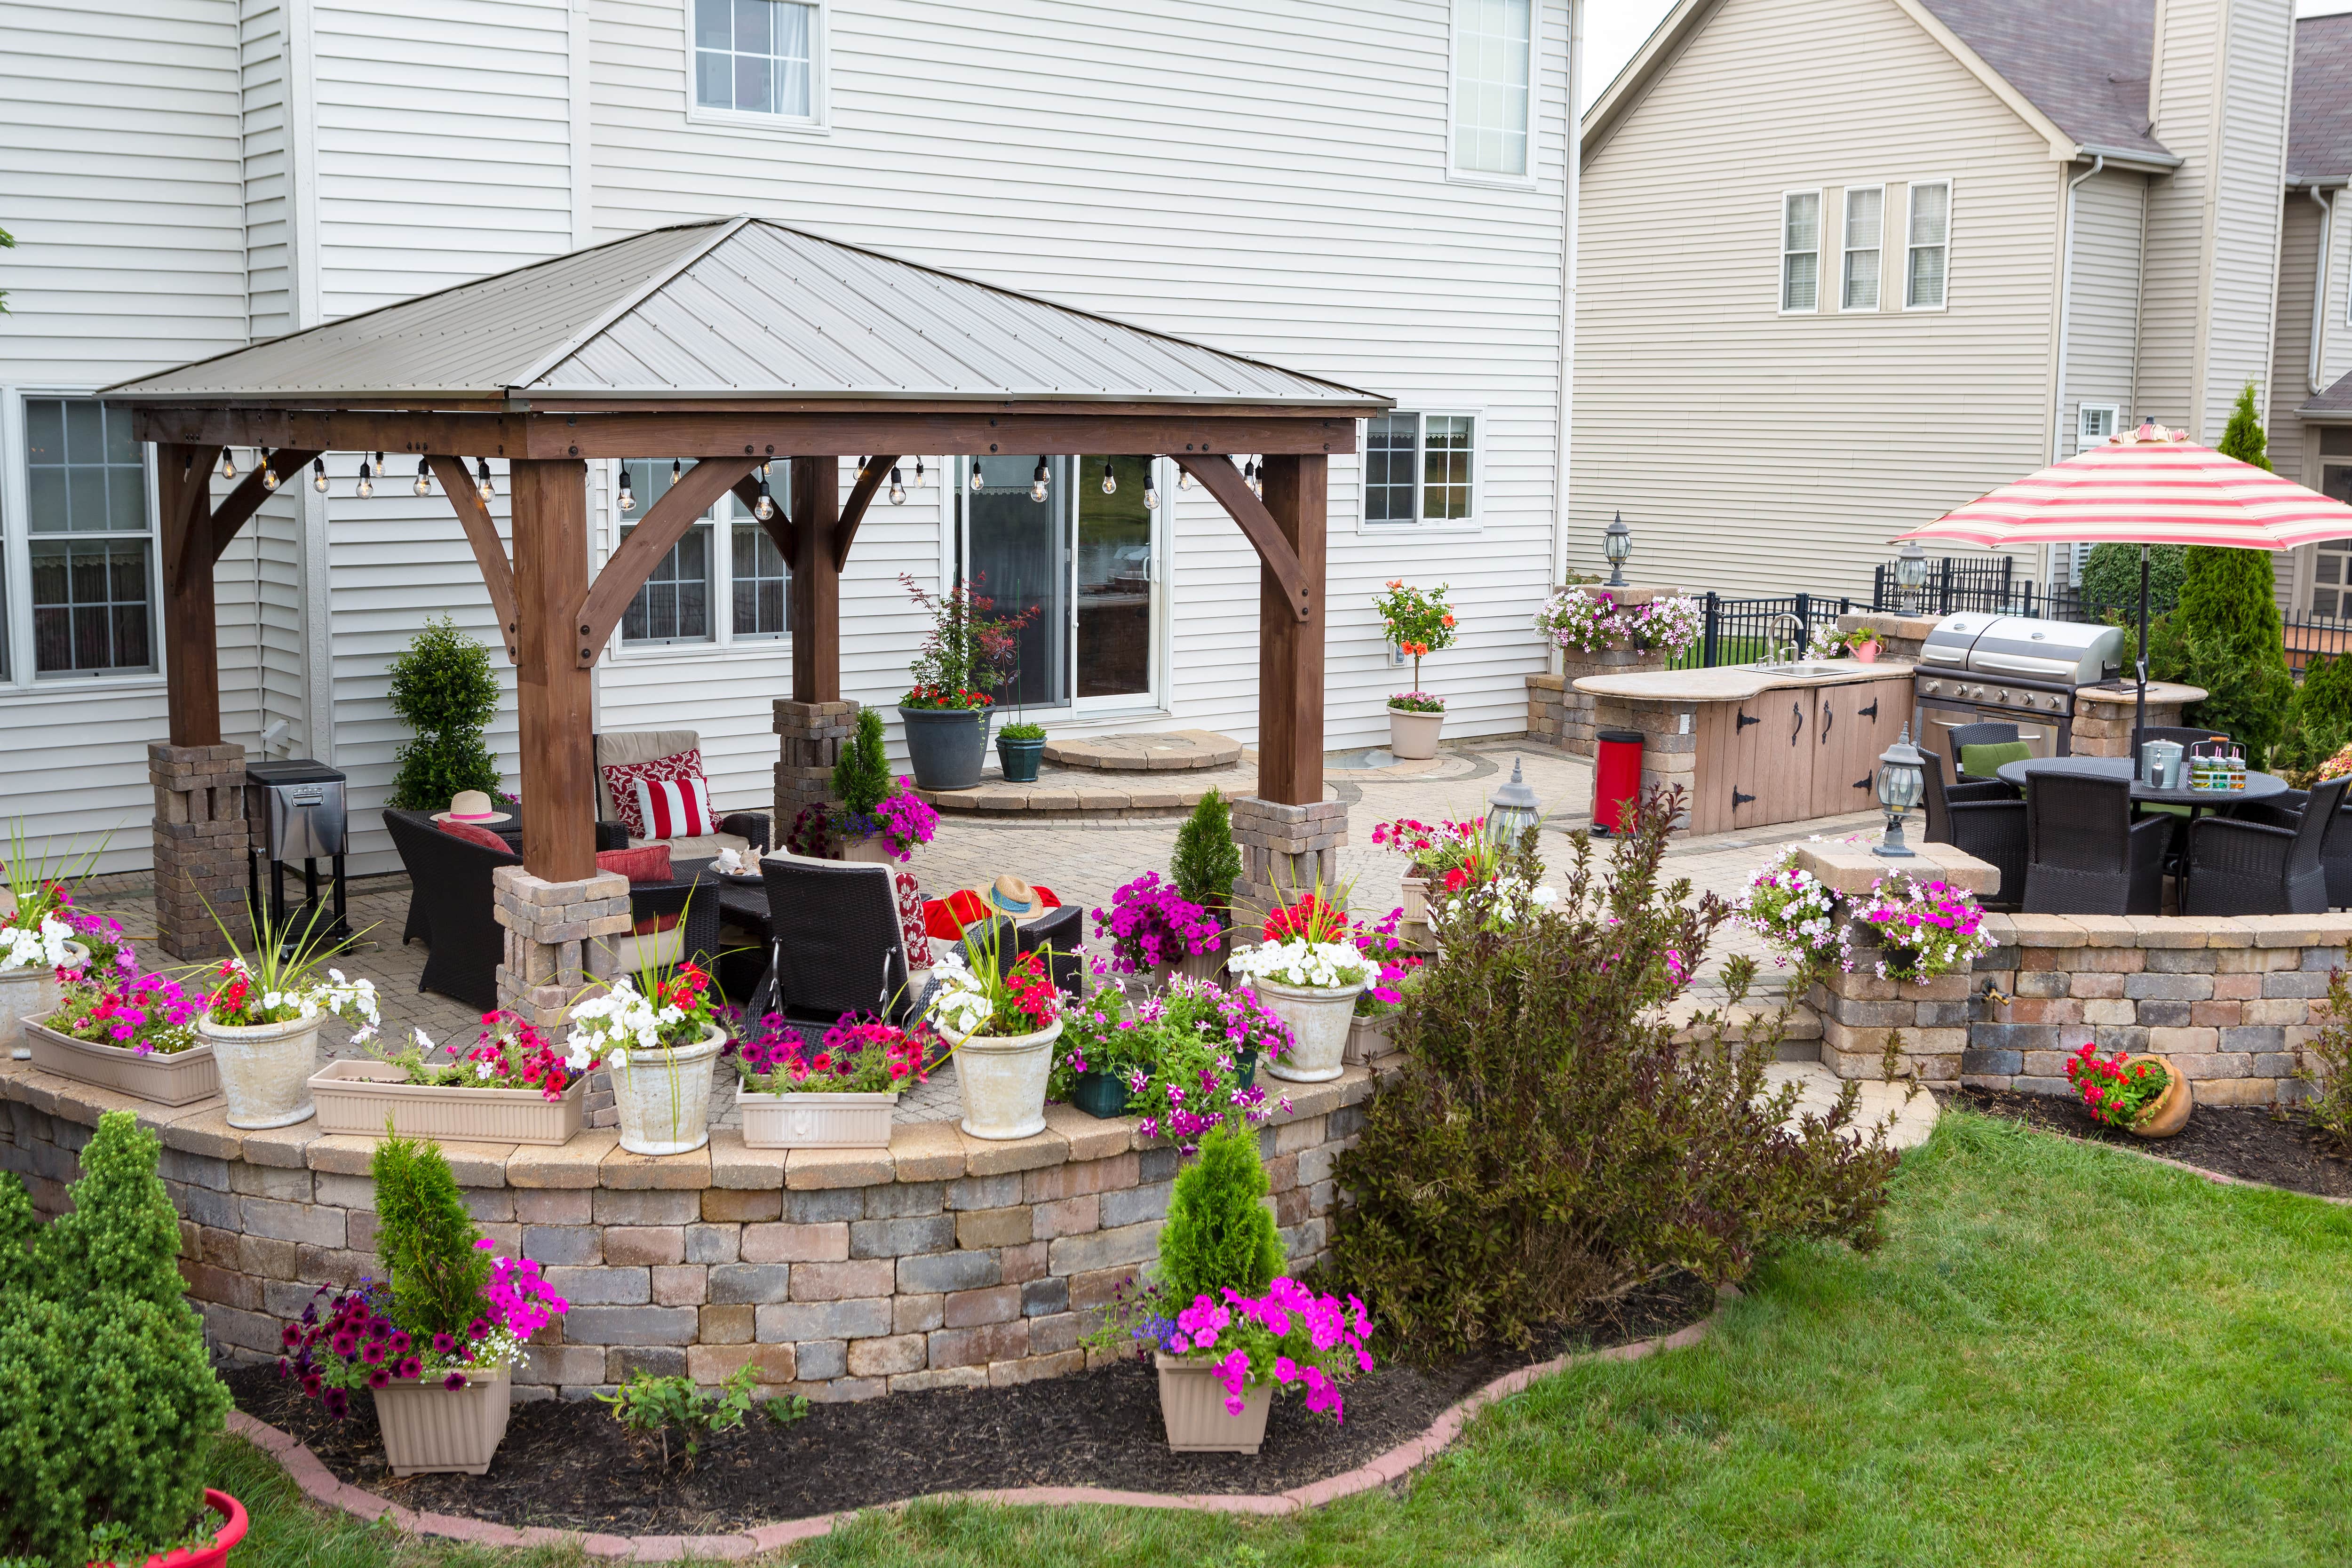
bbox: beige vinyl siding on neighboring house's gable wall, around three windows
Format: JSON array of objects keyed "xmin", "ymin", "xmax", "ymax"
[{"xmin": 1569, "ymin": 0, "xmax": 2063, "ymax": 595}]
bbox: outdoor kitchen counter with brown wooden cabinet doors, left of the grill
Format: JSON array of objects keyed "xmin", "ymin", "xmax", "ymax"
[{"xmin": 1576, "ymin": 658, "xmax": 1912, "ymax": 832}]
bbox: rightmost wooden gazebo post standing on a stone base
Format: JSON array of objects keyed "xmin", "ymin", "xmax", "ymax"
[{"xmin": 1251, "ymin": 454, "xmax": 1331, "ymax": 806}]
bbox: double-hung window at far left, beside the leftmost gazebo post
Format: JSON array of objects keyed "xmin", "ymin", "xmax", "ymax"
[{"xmin": 24, "ymin": 397, "xmax": 155, "ymax": 677}]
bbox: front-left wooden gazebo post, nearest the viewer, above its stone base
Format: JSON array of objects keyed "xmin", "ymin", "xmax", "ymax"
[{"xmin": 510, "ymin": 461, "xmax": 595, "ymax": 882}]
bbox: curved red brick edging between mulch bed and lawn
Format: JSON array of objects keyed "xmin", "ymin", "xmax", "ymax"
[{"xmin": 228, "ymin": 1288, "xmax": 1736, "ymax": 1563}]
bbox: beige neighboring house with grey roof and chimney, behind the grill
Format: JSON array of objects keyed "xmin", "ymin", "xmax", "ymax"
[{"xmin": 1566, "ymin": 0, "xmax": 2324, "ymax": 613}]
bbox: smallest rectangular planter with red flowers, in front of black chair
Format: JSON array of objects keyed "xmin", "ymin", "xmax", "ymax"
[{"xmin": 734, "ymin": 1013, "xmax": 941, "ymax": 1150}]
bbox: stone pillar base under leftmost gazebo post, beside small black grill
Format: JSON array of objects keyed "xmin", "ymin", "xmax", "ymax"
[{"xmin": 148, "ymin": 740, "xmax": 252, "ymax": 959}]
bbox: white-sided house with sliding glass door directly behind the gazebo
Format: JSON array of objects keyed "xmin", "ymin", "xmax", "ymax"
[{"xmin": 0, "ymin": 0, "xmax": 1573, "ymax": 870}]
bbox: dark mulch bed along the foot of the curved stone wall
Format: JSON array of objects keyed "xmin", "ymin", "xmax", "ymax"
[{"xmin": 226, "ymin": 1276, "xmax": 1715, "ymax": 1535}]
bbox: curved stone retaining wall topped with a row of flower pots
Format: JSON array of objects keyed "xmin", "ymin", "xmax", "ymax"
[{"xmin": 0, "ymin": 1060, "xmax": 1374, "ymax": 1399}]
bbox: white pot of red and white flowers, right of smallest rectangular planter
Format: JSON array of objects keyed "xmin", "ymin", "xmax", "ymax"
[{"xmin": 924, "ymin": 924, "xmax": 1061, "ymax": 1138}]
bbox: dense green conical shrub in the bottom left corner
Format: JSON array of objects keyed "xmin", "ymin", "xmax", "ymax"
[{"xmin": 0, "ymin": 1112, "xmax": 228, "ymax": 1568}]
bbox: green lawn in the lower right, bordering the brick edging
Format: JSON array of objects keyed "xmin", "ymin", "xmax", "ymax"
[{"xmin": 223, "ymin": 1114, "xmax": 2352, "ymax": 1568}]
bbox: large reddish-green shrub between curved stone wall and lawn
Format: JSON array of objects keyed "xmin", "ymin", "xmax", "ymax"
[{"xmin": 1331, "ymin": 788, "xmax": 1896, "ymax": 1354}]
